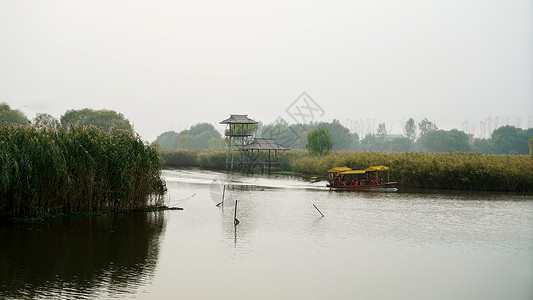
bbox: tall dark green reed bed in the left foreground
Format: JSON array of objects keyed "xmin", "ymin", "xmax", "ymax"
[{"xmin": 0, "ymin": 125, "xmax": 166, "ymax": 217}]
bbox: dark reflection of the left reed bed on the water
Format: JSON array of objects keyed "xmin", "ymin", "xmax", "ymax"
[{"xmin": 0, "ymin": 213, "xmax": 165, "ymax": 299}]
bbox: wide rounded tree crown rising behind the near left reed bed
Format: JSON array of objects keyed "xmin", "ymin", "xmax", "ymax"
[{"xmin": 60, "ymin": 108, "xmax": 133, "ymax": 131}]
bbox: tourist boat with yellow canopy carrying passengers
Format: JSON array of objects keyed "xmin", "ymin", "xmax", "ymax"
[{"xmin": 326, "ymin": 166, "xmax": 397, "ymax": 190}]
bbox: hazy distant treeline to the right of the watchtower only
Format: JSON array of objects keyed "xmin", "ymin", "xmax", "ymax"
[{"xmin": 257, "ymin": 118, "xmax": 533, "ymax": 154}]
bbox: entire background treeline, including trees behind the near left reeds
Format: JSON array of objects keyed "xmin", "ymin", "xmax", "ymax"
[{"xmin": 0, "ymin": 103, "xmax": 533, "ymax": 154}]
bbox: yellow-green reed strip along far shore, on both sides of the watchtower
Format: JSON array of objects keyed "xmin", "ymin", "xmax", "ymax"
[{"xmin": 160, "ymin": 150, "xmax": 533, "ymax": 192}]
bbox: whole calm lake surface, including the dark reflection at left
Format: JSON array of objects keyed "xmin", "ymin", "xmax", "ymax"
[{"xmin": 0, "ymin": 170, "xmax": 533, "ymax": 299}]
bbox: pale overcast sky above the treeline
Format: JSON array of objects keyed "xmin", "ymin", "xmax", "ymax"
[{"xmin": 0, "ymin": 0, "xmax": 533, "ymax": 141}]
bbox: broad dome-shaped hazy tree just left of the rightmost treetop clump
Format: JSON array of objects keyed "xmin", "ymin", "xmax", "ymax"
[{"xmin": 422, "ymin": 129, "xmax": 471, "ymax": 152}]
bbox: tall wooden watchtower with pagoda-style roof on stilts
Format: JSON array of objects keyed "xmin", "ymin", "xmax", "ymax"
[{"xmin": 220, "ymin": 115, "xmax": 257, "ymax": 170}]
